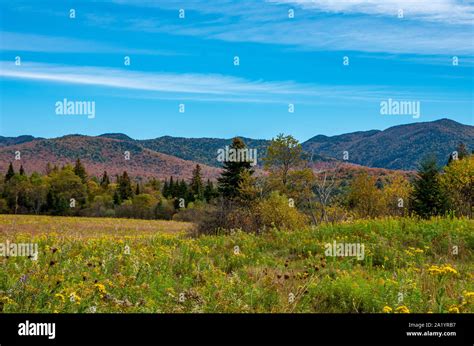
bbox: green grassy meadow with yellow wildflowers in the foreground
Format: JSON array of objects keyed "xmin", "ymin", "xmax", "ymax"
[{"xmin": 0, "ymin": 215, "xmax": 474, "ymax": 313}]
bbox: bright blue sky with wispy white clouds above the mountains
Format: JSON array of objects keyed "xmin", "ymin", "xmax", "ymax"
[{"xmin": 0, "ymin": 0, "xmax": 474, "ymax": 141}]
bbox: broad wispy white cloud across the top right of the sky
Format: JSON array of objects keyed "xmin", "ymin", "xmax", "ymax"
[{"xmin": 107, "ymin": 0, "xmax": 474, "ymax": 55}]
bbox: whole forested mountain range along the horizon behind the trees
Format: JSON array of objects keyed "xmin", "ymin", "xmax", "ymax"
[{"xmin": 0, "ymin": 119, "xmax": 474, "ymax": 179}]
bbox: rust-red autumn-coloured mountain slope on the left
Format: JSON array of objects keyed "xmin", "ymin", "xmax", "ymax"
[{"xmin": 0, "ymin": 135, "xmax": 219, "ymax": 179}]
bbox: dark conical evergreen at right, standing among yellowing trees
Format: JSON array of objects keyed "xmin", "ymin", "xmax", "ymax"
[{"xmin": 410, "ymin": 157, "xmax": 447, "ymax": 218}]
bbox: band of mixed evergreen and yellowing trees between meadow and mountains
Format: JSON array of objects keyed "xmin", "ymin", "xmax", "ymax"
[{"xmin": 0, "ymin": 134, "xmax": 474, "ymax": 233}]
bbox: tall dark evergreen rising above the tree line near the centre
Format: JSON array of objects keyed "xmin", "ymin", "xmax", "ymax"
[{"xmin": 217, "ymin": 137, "xmax": 253, "ymax": 199}]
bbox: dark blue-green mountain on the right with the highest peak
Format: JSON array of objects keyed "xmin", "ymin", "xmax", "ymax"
[{"xmin": 303, "ymin": 119, "xmax": 474, "ymax": 170}]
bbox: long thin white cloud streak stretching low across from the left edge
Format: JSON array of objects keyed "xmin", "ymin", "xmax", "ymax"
[{"xmin": 0, "ymin": 61, "xmax": 465, "ymax": 104}]
